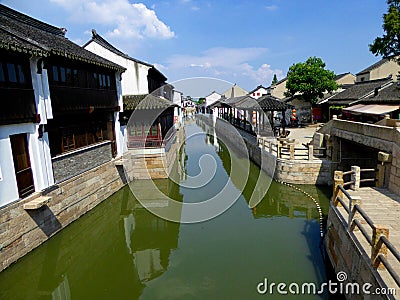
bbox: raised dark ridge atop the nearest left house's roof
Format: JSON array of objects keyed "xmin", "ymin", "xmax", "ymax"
[{"xmin": 0, "ymin": 4, "xmax": 67, "ymax": 36}]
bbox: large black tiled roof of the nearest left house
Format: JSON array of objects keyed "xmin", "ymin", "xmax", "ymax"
[{"xmin": 0, "ymin": 4, "xmax": 125, "ymax": 71}]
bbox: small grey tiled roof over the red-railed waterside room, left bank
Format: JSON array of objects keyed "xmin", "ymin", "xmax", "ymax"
[{"xmin": 122, "ymin": 94, "xmax": 177, "ymax": 110}]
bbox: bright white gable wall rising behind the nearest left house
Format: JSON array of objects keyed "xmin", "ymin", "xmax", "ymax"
[{"xmin": 85, "ymin": 41, "xmax": 151, "ymax": 95}]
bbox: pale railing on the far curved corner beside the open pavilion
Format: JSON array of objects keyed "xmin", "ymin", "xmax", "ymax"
[{"xmin": 258, "ymin": 138, "xmax": 327, "ymax": 161}]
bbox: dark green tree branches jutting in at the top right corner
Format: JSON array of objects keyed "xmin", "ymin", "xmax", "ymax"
[{"xmin": 369, "ymin": 0, "xmax": 400, "ymax": 63}]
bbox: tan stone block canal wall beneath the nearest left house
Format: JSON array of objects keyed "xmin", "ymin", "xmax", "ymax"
[{"xmin": 0, "ymin": 160, "xmax": 126, "ymax": 271}]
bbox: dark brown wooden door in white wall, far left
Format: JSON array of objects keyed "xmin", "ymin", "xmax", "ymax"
[{"xmin": 10, "ymin": 134, "xmax": 35, "ymax": 198}]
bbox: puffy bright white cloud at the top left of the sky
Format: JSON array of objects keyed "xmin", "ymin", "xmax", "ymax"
[{"xmin": 51, "ymin": 0, "xmax": 175, "ymax": 39}]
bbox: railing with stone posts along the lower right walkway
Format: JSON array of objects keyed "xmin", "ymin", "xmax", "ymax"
[{"xmin": 332, "ymin": 166, "xmax": 400, "ymax": 287}]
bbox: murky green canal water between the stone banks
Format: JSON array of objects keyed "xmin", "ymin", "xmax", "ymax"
[{"xmin": 0, "ymin": 120, "xmax": 328, "ymax": 299}]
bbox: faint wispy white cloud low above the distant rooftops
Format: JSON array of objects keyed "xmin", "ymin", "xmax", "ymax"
[{"xmin": 165, "ymin": 47, "xmax": 283, "ymax": 88}]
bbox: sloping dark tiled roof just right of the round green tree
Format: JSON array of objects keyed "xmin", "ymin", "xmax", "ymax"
[{"xmin": 328, "ymin": 78, "xmax": 392, "ymax": 104}]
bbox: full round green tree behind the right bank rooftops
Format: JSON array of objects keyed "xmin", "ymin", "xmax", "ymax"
[{"xmin": 285, "ymin": 57, "xmax": 339, "ymax": 104}]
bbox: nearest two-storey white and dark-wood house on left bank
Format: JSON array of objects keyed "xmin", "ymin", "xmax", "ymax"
[{"xmin": 0, "ymin": 5, "xmax": 125, "ymax": 206}]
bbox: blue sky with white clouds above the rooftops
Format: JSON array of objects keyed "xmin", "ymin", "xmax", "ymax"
[{"xmin": 0, "ymin": 0, "xmax": 387, "ymax": 90}]
